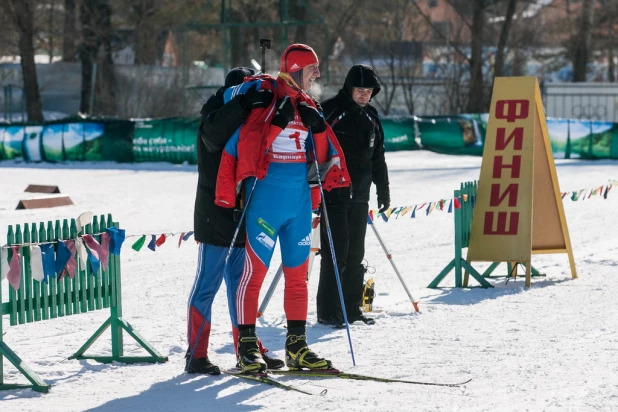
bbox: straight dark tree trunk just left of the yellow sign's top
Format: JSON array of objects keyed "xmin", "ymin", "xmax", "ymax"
[{"xmin": 466, "ymin": 0, "xmax": 485, "ymax": 113}]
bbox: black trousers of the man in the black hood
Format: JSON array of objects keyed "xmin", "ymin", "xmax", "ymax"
[{"xmin": 317, "ymin": 201, "xmax": 369, "ymax": 319}]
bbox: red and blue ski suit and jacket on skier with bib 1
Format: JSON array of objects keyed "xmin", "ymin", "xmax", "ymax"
[{"xmin": 215, "ymin": 75, "xmax": 350, "ymax": 325}]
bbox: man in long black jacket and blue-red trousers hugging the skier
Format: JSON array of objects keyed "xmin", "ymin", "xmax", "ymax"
[{"xmin": 185, "ymin": 67, "xmax": 283, "ymax": 375}]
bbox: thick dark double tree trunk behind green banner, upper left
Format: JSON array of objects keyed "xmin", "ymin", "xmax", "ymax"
[{"xmin": 79, "ymin": 0, "xmax": 116, "ymax": 116}]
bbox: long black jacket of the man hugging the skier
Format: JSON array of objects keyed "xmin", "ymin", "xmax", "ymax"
[{"xmin": 193, "ymin": 67, "xmax": 253, "ymax": 247}]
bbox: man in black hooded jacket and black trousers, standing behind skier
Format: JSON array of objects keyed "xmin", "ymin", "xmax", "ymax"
[{"xmin": 317, "ymin": 64, "xmax": 390, "ymax": 325}]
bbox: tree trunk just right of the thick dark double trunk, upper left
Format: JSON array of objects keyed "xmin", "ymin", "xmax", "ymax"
[{"xmin": 133, "ymin": 0, "xmax": 158, "ymax": 65}]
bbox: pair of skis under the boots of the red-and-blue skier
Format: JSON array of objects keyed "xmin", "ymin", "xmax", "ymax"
[{"xmin": 223, "ymin": 369, "xmax": 472, "ymax": 395}]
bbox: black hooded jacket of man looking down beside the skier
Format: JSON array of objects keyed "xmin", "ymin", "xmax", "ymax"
[{"xmin": 322, "ymin": 64, "xmax": 390, "ymax": 203}]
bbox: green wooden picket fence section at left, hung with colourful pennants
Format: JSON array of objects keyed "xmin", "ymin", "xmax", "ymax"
[{"xmin": 0, "ymin": 215, "xmax": 167, "ymax": 392}]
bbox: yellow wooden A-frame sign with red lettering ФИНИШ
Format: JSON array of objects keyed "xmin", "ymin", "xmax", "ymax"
[{"xmin": 464, "ymin": 77, "xmax": 577, "ymax": 287}]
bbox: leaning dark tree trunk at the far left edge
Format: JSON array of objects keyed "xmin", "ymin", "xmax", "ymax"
[{"xmin": 0, "ymin": 0, "xmax": 44, "ymax": 122}]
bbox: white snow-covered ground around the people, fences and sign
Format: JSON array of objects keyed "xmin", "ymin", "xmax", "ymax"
[{"xmin": 0, "ymin": 152, "xmax": 618, "ymax": 412}]
